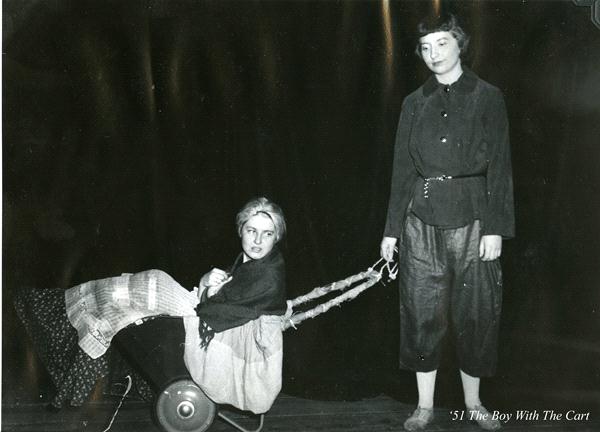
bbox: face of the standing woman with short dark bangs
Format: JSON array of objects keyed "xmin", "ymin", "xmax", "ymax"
[{"xmin": 419, "ymin": 32, "xmax": 462, "ymax": 76}]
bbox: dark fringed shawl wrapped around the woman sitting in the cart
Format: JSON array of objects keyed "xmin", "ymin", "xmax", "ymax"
[{"xmin": 196, "ymin": 247, "xmax": 287, "ymax": 332}]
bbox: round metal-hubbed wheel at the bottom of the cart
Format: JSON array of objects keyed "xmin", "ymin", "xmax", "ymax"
[{"xmin": 154, "ymin": 379, "xmax": 217, "ymax": 432}]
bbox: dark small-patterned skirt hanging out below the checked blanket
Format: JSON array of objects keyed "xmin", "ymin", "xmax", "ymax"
[{"xmin": 15, "ymin": 289, "xmax": 152, "ymax": 408}]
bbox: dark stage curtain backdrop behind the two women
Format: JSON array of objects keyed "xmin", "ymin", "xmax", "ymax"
[{"xmin": 2, "ymin": 0, "xmax": 600, "ymax": 409}]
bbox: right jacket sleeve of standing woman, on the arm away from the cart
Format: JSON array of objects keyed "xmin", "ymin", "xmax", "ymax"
[{"xmin": 482, "ymin": 89, "xmax": 515, "ymax": 238}]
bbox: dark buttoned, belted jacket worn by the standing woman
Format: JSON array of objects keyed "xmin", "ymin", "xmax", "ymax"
[{"xmin": 384, "ymin": 68, "xmax": 515, "ymax": 238}]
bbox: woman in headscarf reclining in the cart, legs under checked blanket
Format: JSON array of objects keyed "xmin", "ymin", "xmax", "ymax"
[{"xmin": 15, "ymin": 198, "xmax": 286, "ymax": 408}]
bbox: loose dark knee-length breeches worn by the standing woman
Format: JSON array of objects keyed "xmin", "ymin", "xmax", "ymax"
[{"xmin": 399, "ymin": 213, "xmax": 502, "ymax": 376}]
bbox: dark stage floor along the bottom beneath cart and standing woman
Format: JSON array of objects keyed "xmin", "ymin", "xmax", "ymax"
[{"xmin": 2, "ymin": 394, "xmax": 600, "ymax": 432}]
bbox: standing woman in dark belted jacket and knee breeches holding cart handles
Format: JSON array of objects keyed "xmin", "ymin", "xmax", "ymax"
[{"xmin": 381, "ymin": 15, "xmax": 514, "ymax": 431}]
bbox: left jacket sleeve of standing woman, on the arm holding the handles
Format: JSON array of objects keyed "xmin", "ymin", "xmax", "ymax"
[{"xmin": 383, "ymin": 98, "xmax": 417, "ymax": 238}]
